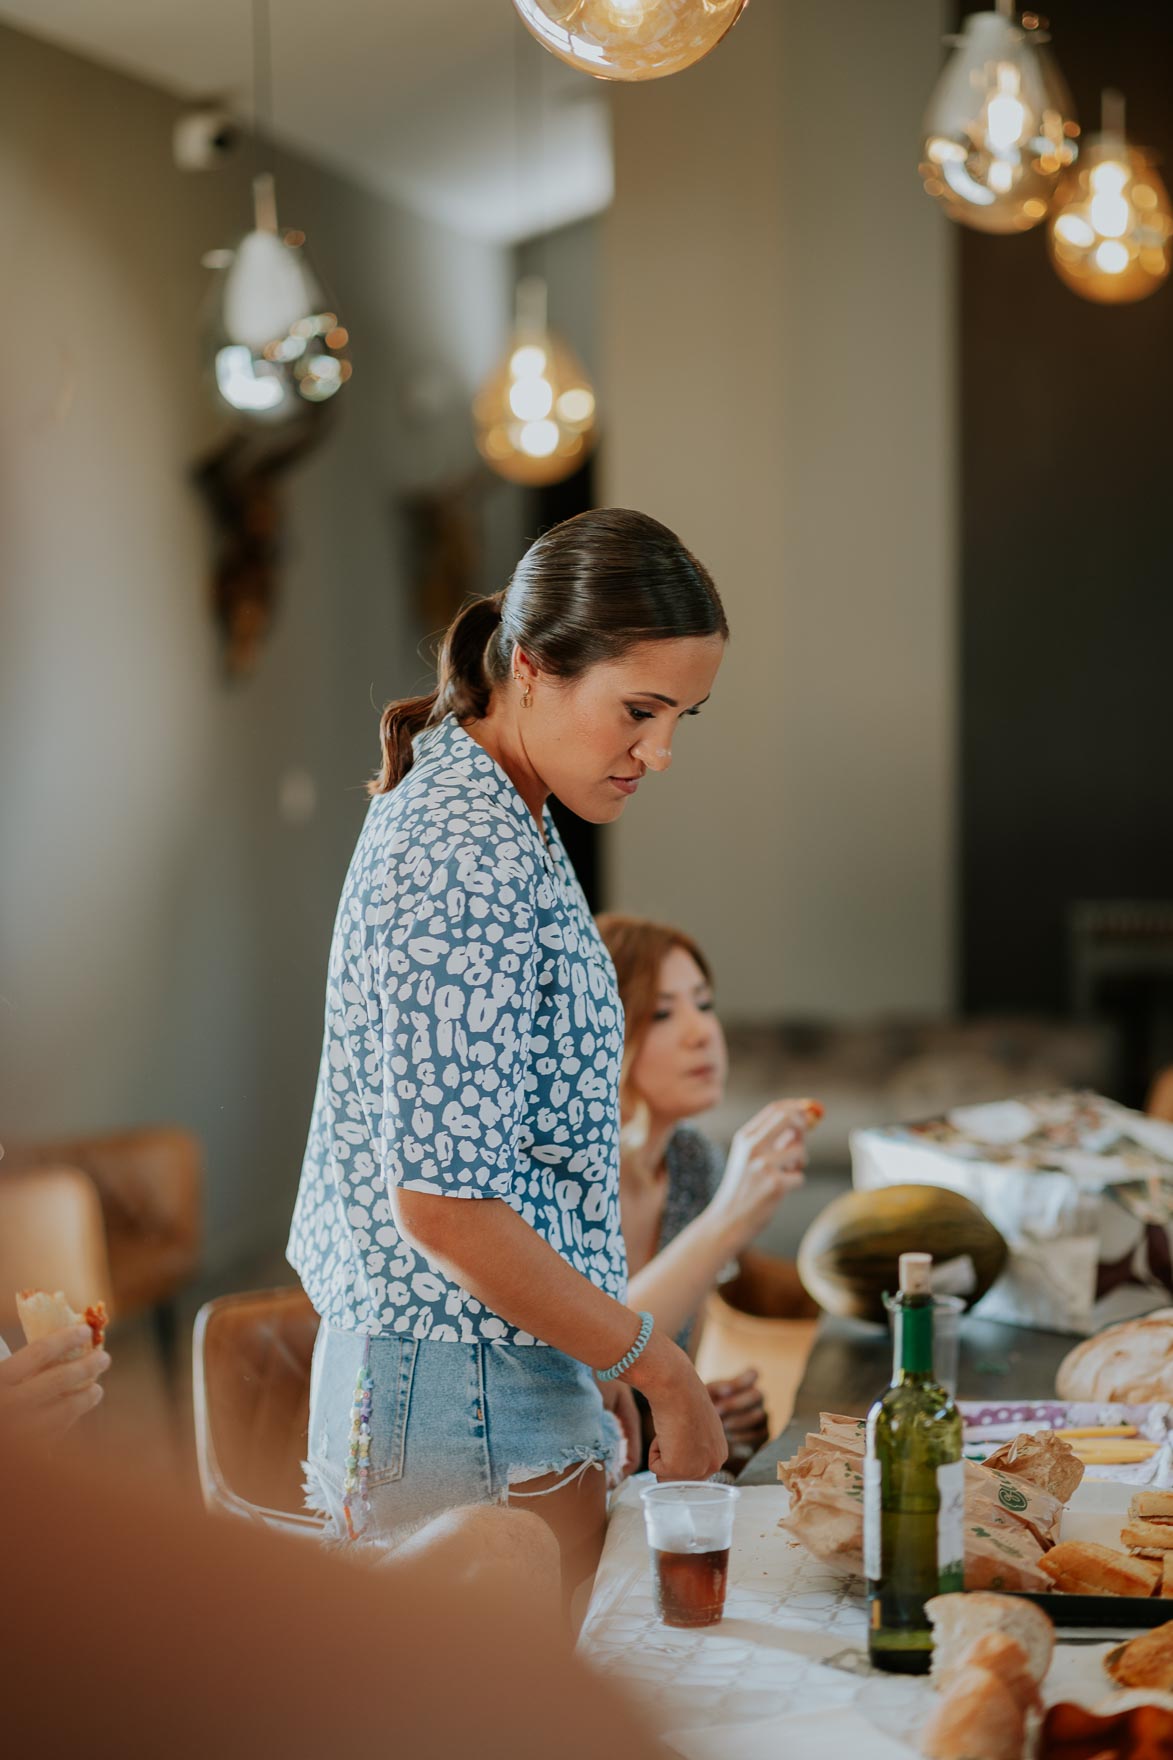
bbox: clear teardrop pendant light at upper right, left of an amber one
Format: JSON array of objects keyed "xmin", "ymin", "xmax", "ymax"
[{"xmin": 921, "ymin": 0, "xmax": 1080, "ymax": 232}]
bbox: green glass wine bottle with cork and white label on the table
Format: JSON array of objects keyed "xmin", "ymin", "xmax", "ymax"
[{"xmin": 863, "ymin": 1253, "xmax": 965, "ymax": 1674}]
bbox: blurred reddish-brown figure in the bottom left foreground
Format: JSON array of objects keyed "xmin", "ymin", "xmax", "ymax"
[{"xmin": 0, "ymin": 1436, "xmax": 660, "ymax": 1760}]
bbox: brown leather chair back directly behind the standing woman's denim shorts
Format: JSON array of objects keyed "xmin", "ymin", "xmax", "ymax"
[{"xmin": 192, "ymin": 1285, "xmax": 326, "ymax": 1535}]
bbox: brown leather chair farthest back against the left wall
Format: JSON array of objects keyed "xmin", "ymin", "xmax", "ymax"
[{"xmin": 0, "ymin": 1125, "xmax": 203, "ymax": 1373}]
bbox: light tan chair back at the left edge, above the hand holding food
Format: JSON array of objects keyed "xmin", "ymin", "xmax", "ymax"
[{"xmin": 0, "ymin": 1167, "xmax": 114, "ymax": 1341}]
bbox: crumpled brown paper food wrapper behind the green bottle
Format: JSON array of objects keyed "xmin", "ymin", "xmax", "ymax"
[{"xmin": 778, "ymin": 1413, "xmax": 1081, "ymax": 1591}]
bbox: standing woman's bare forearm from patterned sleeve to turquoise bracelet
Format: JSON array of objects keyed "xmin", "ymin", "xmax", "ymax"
[{"xmin": 391, "ymin": 1190, "xmax": 671, "ymax": 1390}]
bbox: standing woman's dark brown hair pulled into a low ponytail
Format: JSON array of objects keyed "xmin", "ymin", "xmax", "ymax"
[{"xmin": 368, "ymin": 507, "xmax": 729, "ymax": 794}]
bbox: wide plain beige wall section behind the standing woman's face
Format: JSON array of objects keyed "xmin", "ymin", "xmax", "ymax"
[{"xmin": 602, "ymin": 0, "xmax": 956, "ymax": 1019}]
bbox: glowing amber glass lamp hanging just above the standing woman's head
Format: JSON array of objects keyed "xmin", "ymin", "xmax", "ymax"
[{"xmin": 472, "ymin": 276, "xmax": 595, "ymax": 488}]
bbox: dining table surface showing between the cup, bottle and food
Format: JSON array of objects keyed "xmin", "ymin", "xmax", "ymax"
[{"xmin": 579, "ymin": 1315, "xmax": 1091, "ymax": 1760}]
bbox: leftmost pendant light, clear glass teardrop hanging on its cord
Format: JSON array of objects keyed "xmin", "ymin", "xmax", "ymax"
[{"xmin": 204, "ymin": 0, "xmax": 350, "ymax": 424}]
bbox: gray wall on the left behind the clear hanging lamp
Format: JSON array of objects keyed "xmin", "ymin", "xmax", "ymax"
[{"xmin": 0, "ymin": 32, "xmax": 513, "ymax": 1262}]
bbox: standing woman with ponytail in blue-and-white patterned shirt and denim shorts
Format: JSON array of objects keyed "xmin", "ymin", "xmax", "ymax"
[{"xmin": 289, "ymin": 509, "xmax": 727, "ymax": 1598}]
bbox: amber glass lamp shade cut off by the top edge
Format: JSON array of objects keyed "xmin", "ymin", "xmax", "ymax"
[{"xmin": 513, "ymin": 0, "xmax": 750, "ymax": 79}]
